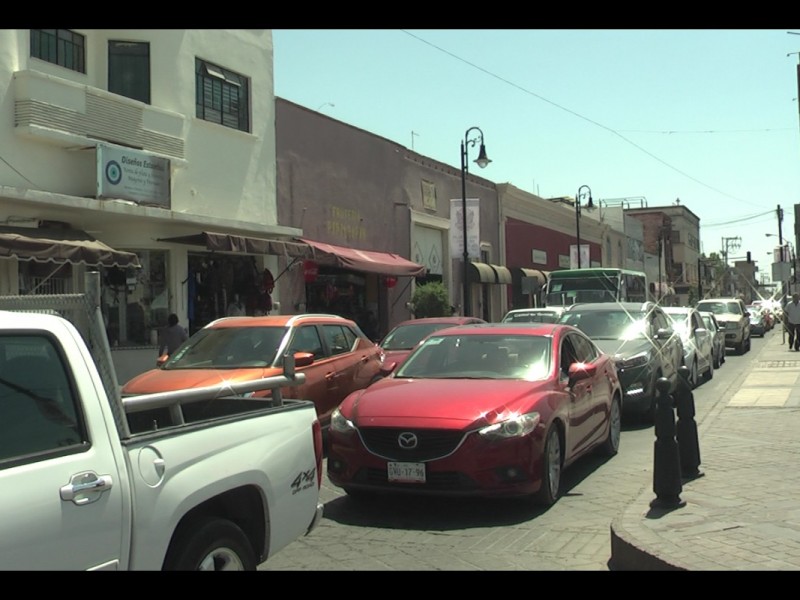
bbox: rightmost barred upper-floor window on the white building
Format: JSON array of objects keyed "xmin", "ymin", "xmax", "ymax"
[{"xmin": 195, "ymin": 58, "xmax": 250, "ymax": 132}]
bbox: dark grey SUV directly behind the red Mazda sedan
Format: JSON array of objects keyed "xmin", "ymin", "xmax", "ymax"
[{"xmin": 559, "ymin": 302, "xmax": 683, "ymax": 423}]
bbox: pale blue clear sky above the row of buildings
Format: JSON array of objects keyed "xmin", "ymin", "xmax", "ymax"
[{"xmin": 272, "ymin": 28, "xmax": 800, "ymax": 281}]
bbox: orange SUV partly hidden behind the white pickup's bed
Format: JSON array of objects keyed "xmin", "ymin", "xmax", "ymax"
[{"xmin": 122, "ymin": 314, "xmax": 383, "ymax": 428}]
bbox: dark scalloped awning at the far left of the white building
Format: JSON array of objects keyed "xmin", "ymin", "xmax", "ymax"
[{"xmin": 0, "ymin": 226, "xmax": 141, "ymax": 268}]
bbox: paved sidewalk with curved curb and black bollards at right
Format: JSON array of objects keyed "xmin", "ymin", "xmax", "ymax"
[{"xmin": 609, "ymin": 328, "xmax": 800, "ymax": 571}]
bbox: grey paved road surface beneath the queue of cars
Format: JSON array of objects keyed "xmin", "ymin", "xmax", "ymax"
[{"xmin": 259, "ymin": 330, "xmax": 764, "ymax": 571}]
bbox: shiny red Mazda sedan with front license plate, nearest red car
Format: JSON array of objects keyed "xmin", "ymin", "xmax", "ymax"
[{"xmin": 327, "ymin": 323, "xmax": 622, "ymax": 505}]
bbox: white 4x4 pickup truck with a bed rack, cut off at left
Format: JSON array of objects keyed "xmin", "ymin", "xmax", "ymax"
[{"xmin": 0, "ymin": 310, "xmax": 323, "ymax": 570}]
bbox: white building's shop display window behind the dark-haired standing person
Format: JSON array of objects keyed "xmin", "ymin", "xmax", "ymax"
[{"xmin": 101, "ymin": 250, "xmax": 171, "ymax": 346}]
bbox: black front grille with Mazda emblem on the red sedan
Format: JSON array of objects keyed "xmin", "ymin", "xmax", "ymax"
[{"xmin": 358, "ymin": 427, "xmax": 468, "ymax": 462}]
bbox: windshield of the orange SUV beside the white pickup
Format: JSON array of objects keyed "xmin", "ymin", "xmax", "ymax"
[{"xmin": 163, "ymin": 327, "xmax": 288, "ymax": 370}]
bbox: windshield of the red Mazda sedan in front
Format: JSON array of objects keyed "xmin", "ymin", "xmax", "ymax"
[{"xmin": 395, "ymin": 335, "xmax": 552, "ymax": 381}]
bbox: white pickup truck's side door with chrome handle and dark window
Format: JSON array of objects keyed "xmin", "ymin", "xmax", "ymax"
[{"xmin": 0, "ymin": 334, "xmax": 125, "ymax": 570}]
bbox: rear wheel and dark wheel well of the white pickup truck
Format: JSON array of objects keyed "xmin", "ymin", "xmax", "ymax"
[{"xmin": 164, "ymin": 517, "xmax": 253, "ymax": 571}]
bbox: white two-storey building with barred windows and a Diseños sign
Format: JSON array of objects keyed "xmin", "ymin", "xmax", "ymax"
[{"xmin": 0, "ymin": 29, "xmax": 302, "ymax": 381}]
